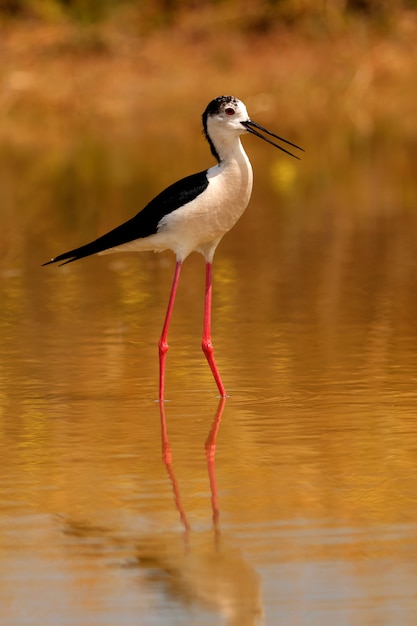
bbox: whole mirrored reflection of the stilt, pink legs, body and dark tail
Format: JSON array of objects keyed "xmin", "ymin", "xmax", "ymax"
[{"xmin": 60, "ymin": 398, "xmax": 263, "ymax": 626}]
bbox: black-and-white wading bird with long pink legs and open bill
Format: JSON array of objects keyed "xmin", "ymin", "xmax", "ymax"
[{"xmin": 44, "ymin": 96, "xmax": 302, "ymax": 401}]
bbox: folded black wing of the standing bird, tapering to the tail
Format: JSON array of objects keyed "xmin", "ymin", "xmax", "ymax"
[{"xmin": 43, "ymin": 170, "xmax": 208, "ymax": 265}]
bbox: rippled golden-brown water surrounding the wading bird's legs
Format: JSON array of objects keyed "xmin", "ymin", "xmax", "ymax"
[{"xmin": 0, "ymin": 135, "xmax": 417, "ymax": 626}]
